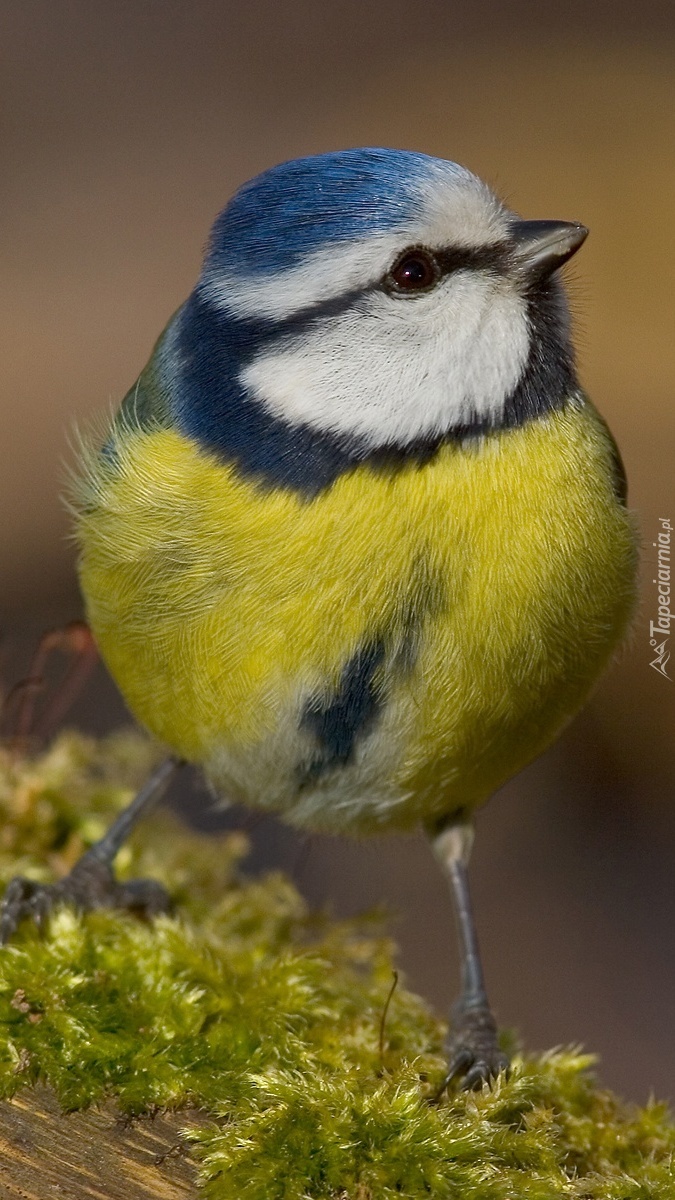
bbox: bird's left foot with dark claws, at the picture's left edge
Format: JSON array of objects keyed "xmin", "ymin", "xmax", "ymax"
[{"xmin": 0, "ymin": 852, "xmax": 171, "ymax": 946}]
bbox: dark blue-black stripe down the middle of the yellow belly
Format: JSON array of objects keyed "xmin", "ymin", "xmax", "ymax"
[{"xmin": 300, "ymin": 640, "xmax": 384, "ymax": 779}]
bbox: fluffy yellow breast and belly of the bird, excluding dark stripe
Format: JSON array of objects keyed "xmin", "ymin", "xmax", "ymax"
[{"xmin": 74, "ymin": 404, "xmax": 637, "ymax": 832}]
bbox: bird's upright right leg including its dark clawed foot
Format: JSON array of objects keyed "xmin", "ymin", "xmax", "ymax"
[{"xmin": 434, "ymin": 823, "xmax": 508, "ymax": 1096}]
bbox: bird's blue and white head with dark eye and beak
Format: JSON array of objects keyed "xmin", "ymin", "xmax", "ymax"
[{"xmin": 170, "ymin": 149, "xmax": 587, "ymax": 487}]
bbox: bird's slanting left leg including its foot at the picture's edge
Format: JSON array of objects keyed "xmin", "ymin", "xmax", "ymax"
[{"xmin": 0, "ymin": 758, "xmax": 181, "ymax": 944}]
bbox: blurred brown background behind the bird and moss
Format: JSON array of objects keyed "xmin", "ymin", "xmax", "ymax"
[{"xmin": 0, "ymin": 0, "xmax": 675, "ymax": 1099}]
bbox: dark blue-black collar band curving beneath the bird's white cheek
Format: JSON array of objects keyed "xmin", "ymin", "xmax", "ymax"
[{"xmin": 170, "ymin": 277, "xmax": 579, "ymax": 498}]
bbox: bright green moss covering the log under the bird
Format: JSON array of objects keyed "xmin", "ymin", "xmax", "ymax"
[{"xmin": 0, "ymin": 734, "xmax": 675, "ymax": 1200}]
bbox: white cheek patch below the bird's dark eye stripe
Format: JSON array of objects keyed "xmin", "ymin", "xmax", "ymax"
[{"xmin": 240, "ymin": 271, "xmax": 530, "ymax": 446}]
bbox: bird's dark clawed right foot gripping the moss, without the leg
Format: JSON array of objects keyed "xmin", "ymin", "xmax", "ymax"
[{"xmin": 435, "ymin": 1001, "xmax": 509, "ymax": 1099}]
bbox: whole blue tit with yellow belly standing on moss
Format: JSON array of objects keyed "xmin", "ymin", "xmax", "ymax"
[{"xmin": 0, "ymin": 148, "xmax": 638, "ymax": 1088}]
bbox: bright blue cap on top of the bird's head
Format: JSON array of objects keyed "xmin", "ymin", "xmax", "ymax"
[{"xmin": 204, "ymin": 148, "xmax": 471, "ymax": 276}]
